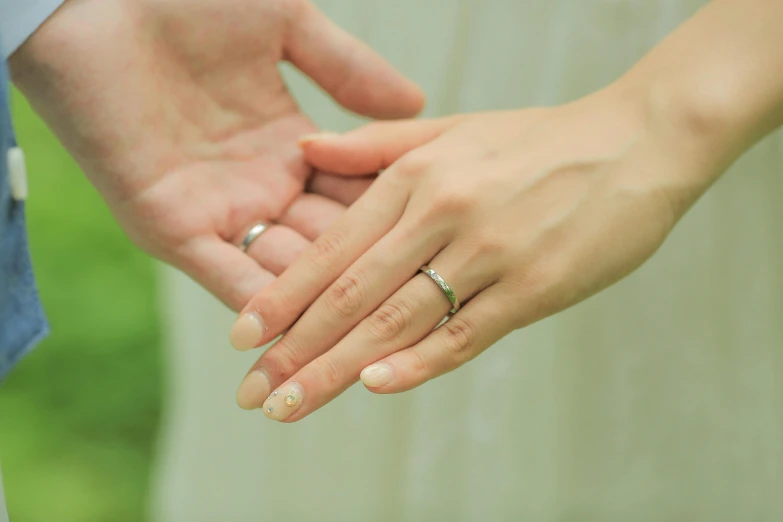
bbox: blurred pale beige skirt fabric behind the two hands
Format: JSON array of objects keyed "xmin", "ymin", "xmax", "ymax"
[{"xmin": 152, "ymin": 0, "xmax": 783, "ymax": 522}]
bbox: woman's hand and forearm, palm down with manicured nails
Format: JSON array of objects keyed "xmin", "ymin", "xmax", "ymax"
[{"xmin": 232, "ymin": 0, "xmax": 783, "ymax": 422}]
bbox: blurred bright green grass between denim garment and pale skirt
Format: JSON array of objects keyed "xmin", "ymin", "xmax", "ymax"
[{"xmin": 0, "ymin": 93, "xmax": 161, "ymax": 522}]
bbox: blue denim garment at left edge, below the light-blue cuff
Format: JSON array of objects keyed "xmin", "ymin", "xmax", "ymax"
[{"xmin": 0, "ymin": 61, "xmax": 49, "ymax": 381}]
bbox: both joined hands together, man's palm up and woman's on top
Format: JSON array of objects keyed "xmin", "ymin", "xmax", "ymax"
[{"xmin": 11, "ymin": 0, "xmax": 728, "ymax": 422}]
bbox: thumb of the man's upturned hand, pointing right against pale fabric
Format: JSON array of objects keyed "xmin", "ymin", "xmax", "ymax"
[{"xmin": 284, "ymin": 1, "xmax": 424, "ymax": 119}]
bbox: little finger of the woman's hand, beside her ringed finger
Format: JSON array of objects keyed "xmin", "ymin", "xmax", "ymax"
[{"xmin": 361, "ymin": 285, "xmax": 514, "ymax": 393}]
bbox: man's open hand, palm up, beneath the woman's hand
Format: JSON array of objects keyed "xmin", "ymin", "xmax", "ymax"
[{"xmin": 10, "ymin": 0, "xmax": 423, "ymax": 309}]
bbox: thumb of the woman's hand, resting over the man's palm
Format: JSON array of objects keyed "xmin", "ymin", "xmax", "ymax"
[{"xmin": 299, "ymin": 116, "xmax": 458, "ymax": 176}]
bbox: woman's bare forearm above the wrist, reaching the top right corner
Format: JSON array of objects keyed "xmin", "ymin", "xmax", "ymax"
[{"xmin": 618, "ymin": 0, "xmax": 783, "ymax": 172}]
